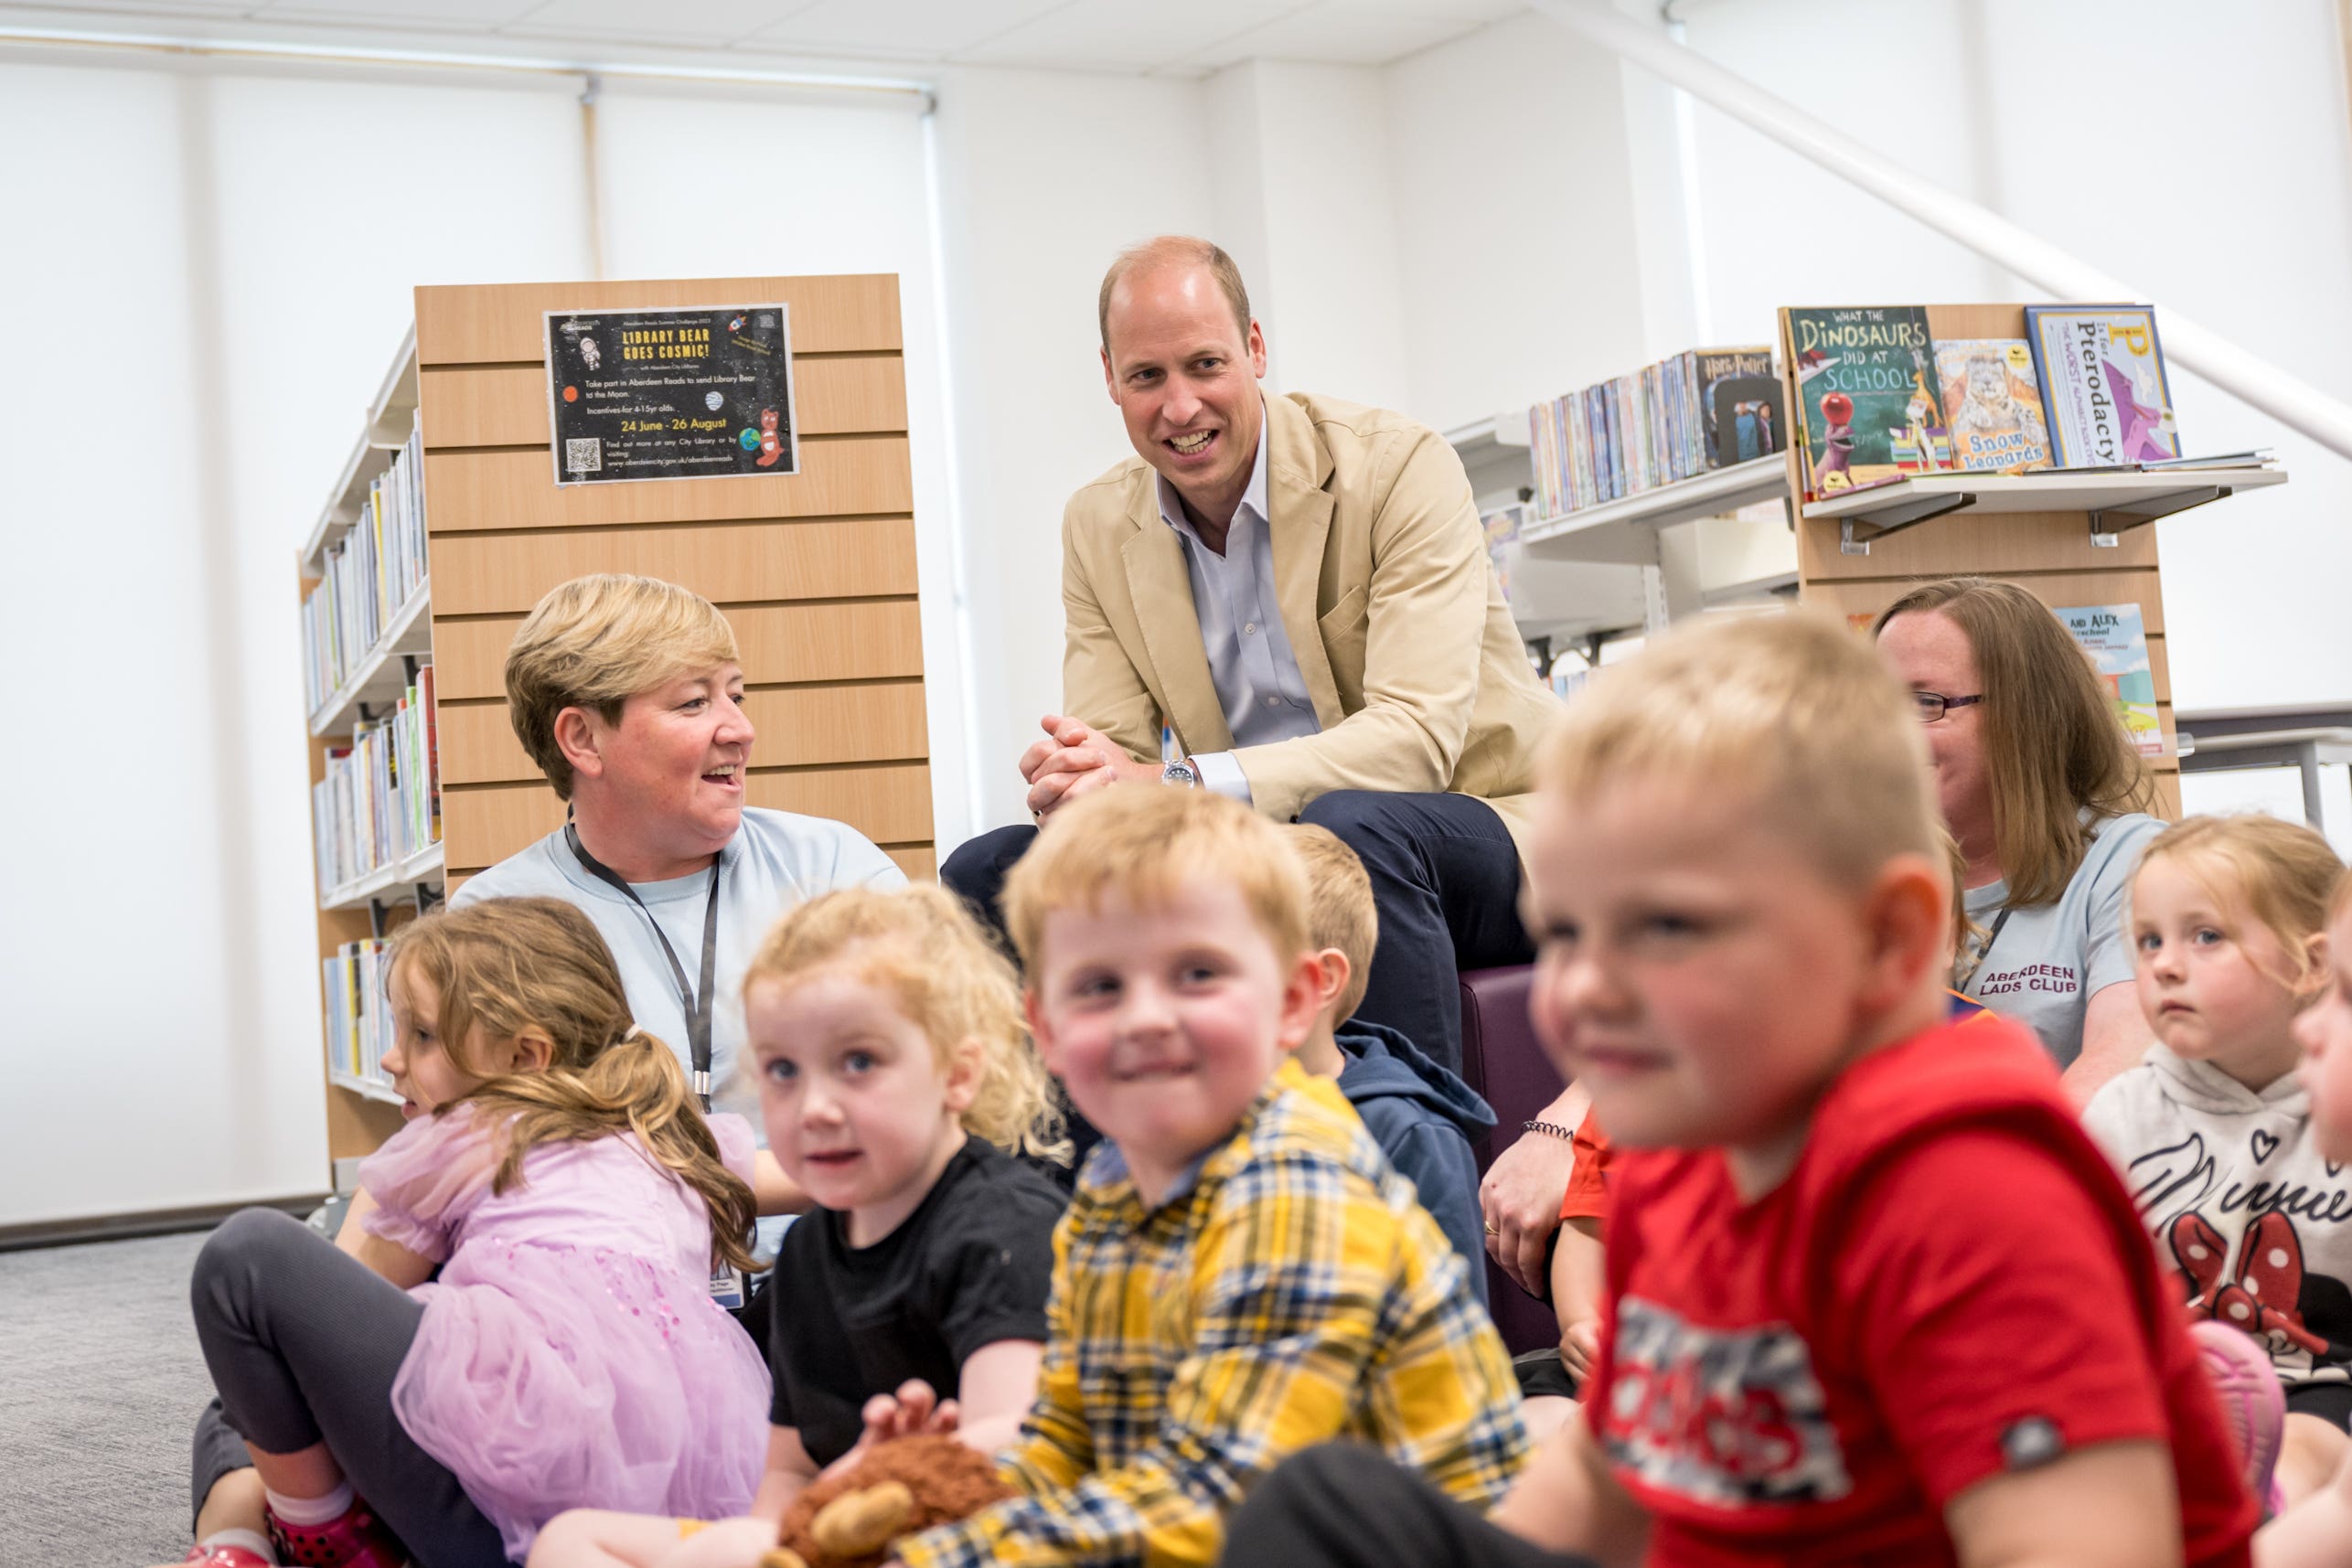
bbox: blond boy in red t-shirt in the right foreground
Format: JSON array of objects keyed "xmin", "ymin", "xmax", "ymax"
[{"xmin": 1225, "ymin": 613, "xmax": 2256, "ymax": 1568}]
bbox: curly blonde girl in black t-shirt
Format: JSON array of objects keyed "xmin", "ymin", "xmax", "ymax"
[{"xmin": 531, "ymin": 886, "xmax": 1068, "ymax": 1568}]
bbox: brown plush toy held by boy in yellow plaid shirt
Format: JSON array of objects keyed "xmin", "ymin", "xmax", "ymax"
[{"xmin": 760, "ymin": 1434, "xmax": 1014, "ymax": 1568}]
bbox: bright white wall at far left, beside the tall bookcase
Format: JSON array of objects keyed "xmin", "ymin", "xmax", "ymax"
[{"xmin": 0, "ymin": 63, "xmax": 593, "ymax": 1225}]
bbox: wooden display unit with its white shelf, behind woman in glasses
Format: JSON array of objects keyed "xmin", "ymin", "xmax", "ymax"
[{"xmin": 1780, "ymin": 305, "xmax": 2286, "ymax": 816}]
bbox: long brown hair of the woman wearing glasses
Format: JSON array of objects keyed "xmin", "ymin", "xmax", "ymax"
[{"xmin": 1870, "ymin": 576, "xmax": 2157, "ymax": 905}]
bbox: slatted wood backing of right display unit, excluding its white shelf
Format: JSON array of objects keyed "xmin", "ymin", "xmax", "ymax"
[{"xmin": 1783, "ymin": 305, "xmax": 2180, "ymax": 816}]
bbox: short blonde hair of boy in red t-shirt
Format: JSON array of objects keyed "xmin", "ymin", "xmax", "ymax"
[{"xmin": 1543, "ymin": 609, "xmax": 1948, "ymax": 889}]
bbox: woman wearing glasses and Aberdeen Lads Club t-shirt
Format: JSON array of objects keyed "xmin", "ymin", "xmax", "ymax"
[{"xmin": 1872, "ymin": 576, "xmax": 2164, "ymax": 1104}]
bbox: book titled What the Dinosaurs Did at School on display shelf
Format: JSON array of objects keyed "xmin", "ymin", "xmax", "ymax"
[{"xmin": 1780, "ymin": 305, "xmax": 1954, "ymax": 501}]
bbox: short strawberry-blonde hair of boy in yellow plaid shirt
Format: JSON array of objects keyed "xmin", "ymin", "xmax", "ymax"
[{"xmin": 1004, "ymin": 785, "xmax": 1308, "ymax": 987}]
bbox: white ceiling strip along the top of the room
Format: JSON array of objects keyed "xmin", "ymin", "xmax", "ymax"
[{"xmin": 0, "ymin": 0, "xmax": 1526, "ymax": 75}]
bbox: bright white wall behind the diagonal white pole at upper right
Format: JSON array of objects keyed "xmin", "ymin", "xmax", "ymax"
[{"xmin": 1686, "ymin": 0, "xmax": 2352, "ymax": 710}]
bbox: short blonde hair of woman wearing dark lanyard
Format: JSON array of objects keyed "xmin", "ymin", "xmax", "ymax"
[{"xmin": 506, "ymin": 571, "xmax": 736, "ymax": 799}]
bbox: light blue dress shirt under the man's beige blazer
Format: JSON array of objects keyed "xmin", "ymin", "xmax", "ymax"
[{"xmin": 1157, "ymin": 404, "xmax": 1321, "ymax": 802}]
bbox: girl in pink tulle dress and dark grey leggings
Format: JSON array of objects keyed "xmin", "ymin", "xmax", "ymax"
[{"xmin": 190, "ymin": 898, "xmax": 769, "ymax": 1568}]
